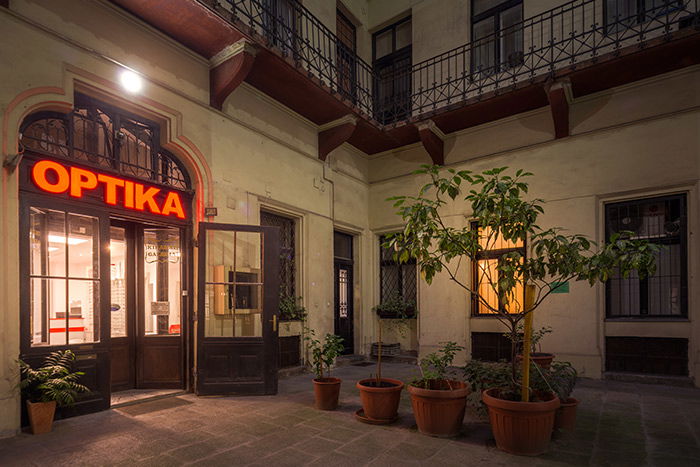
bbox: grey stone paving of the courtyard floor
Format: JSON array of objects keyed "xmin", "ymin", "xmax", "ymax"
[{"xmin": 0, "ymin": 364, "xmax": 700, "ymax": 467}]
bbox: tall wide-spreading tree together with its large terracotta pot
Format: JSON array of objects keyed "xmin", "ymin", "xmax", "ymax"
[{"xmin": 388, "ymin": 166, "xmax": 658, "ymax": 455}]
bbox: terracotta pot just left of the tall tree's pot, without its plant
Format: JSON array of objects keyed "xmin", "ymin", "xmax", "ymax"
[{"xmin": 408, "ymin": 380, "xmax": 469, "ymax": 438}]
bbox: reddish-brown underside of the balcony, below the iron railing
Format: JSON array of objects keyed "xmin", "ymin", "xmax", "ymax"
[{"xmin": 112, "ymin": 0, "xmax": 700, "ymax": 154}]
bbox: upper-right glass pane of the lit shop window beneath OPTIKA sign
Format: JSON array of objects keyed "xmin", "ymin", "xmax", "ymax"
[{"xmin": 67, "ymin": 213, "xmax": 100, "ymax": 279}]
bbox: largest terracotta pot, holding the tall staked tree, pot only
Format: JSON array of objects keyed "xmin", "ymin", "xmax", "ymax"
[{"xmin": 481, "ymin": 388, "xmax": 559, "ymax": 456}]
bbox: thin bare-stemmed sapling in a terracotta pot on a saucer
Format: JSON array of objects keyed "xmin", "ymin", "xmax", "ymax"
[{"xmin": 356, "ymin": 305, "xmax": 407, "ymax": 425}]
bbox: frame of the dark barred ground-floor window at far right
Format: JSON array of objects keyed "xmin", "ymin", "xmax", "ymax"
[{"xmin": 603, "ymin": 193, "xmax": 689, "ymax": 322}]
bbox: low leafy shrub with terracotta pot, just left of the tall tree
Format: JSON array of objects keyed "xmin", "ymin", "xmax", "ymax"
[{"xmin": 408, "ymin": 342, "xmax": 469, "ymax": 438}]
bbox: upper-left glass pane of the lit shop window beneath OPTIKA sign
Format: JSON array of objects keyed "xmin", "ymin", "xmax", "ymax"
[{"xmin": 29, "ymin": 207, "xmax": 66, "ymax": 276}]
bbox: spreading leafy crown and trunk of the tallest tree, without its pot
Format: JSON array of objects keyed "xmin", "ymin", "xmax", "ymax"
[{"xmin": 387, "ymin": 165, "xmax": 659, "ymax": 402}]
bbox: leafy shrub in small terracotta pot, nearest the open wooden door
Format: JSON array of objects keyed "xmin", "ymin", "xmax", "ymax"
[{"xmin": 306, "ymin": 329, "xmax": 344, "ymax": 410}]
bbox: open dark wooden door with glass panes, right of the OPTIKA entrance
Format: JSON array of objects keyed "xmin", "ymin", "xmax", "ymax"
[{"xmin": 195, "ymin": 222, "xmax": 279, "ymax": 395}]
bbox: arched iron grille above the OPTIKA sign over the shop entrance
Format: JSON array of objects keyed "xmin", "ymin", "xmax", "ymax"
[{"xmin": 20, "ymin": 94, "xmax": 190, "ymax": 190}]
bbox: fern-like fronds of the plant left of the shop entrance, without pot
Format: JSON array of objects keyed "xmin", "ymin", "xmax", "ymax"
[{"xmin": 19, "ymin": 350, "xmax": 90, "ymax": 406}]
